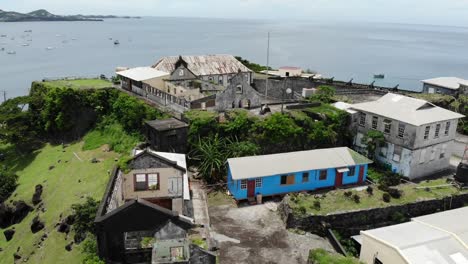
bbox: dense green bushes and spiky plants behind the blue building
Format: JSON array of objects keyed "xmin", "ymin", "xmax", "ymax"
[{"xmin": 185, "ymin": 104, "xmax": 350, "ymax": 182}]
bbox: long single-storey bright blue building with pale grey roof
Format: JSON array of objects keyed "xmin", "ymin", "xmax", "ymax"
[{"xmin": 227, "ymin": 147, "xmax": 372, "ymax": 200}]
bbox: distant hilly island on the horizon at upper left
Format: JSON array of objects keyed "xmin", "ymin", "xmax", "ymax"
[{"xmin": 0, "ymin": 9, "xmax": 141, "ymax": 22}]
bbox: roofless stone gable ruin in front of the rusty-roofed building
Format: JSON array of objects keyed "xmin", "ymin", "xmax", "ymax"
[{"xmin": 215, "ymin": 73, "xmax": 262, "ymax": 111}]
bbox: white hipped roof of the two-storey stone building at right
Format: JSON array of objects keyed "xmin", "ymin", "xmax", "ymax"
[{"xmin": 351, "ymin": 93, "xmax": 464, "ymax": 126}]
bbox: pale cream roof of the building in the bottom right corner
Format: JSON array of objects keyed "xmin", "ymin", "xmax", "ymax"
[{"xmin": 361, "ymin": 207, "xmax": 468, "ymax": 264}]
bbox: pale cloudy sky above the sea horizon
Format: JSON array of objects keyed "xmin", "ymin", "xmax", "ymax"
[{"xmin": 0, "ymin": 0, "xmax": 468, "ymax": 26}]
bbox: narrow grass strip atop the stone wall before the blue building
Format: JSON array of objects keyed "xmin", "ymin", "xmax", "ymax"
[{"xmin": 290, "ymin": 179, "xmax": 467, "ymax": 215}]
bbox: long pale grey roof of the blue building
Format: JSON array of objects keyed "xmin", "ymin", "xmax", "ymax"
[{"xmin": 227, "ymin": 147, "xmax": 372, "ymax": 180}]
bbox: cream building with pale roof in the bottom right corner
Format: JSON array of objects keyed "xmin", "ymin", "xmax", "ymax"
[{"xmin": 356, "ymin": 207, "xmax": 468, "ymax": 264}]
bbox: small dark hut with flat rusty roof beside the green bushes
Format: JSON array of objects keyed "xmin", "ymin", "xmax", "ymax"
[{"xmin": 145, "ymin": 118, "xmax": 188, "ymax": 153}]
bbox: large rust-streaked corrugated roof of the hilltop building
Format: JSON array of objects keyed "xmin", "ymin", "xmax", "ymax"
[{"xmin": 153, "ymin": 54, "xmax": 252, "ymax": 76}]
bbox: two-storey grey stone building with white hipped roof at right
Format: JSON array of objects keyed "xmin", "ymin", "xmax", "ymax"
[{"xmin": 349, "ymin": 93, "xmax": 464, "ymax": 178}]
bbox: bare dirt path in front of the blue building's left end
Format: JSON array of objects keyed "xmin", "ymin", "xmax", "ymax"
[{"xmin": 210, "ymin": 204, "xmax": 333, "ymax": 264}]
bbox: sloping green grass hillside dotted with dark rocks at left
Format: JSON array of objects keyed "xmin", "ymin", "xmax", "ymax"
[{"xmin": 0, "ymin": 142, "xmax": 119, "ymax": 264}]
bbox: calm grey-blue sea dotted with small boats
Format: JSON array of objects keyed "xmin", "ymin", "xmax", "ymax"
[{"xmin": 0, "ymin": 18, "xmax": 468, "ymax": 100}]
